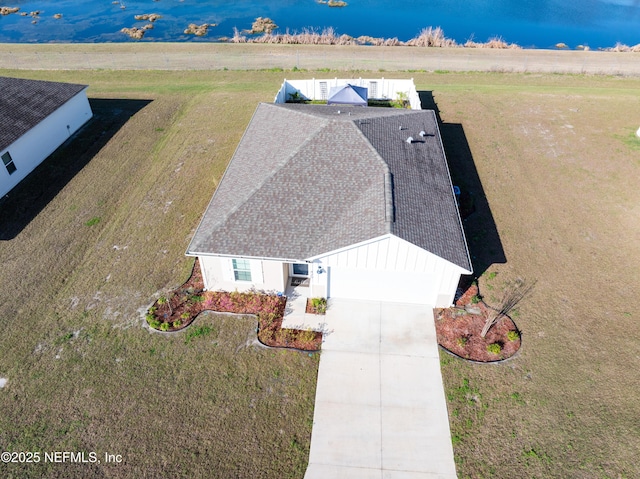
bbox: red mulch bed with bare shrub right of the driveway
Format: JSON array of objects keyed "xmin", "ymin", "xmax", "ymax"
[{"xmin": 434, "ymin": 284, "xmax": 522, "ymax": 363}]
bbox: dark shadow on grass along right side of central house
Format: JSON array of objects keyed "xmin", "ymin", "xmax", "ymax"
[{"xmin": 418, "ymin": 91, "xmax": 507, "ymax": 277}]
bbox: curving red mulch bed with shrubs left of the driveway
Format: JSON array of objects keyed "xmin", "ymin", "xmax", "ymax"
[{"xmin": 147, "ymin": 259, "xmax": 322, "ymax": 351}]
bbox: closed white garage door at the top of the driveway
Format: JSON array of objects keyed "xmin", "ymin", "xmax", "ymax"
[{"xmin": 328, "ymin": 268, "xmax": 438, "ymax": 304}]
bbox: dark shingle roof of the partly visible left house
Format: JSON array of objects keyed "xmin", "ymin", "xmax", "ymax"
[{"xmin": 0, "ymin": 77, "xmax": 87, "ymax": 150}]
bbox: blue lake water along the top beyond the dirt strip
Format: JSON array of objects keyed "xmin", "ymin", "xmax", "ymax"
[{"xmin": 0, "ymin": 0, "xmax": 640, "ymax": 49}]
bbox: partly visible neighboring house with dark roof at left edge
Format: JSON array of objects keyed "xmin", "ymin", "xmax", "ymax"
[{"xmin": 0, "ymin": 77, "xmax": 93, "ymax": 197}]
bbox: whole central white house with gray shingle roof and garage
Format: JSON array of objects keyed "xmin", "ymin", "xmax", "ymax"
[{"xmin": 186, "ymin": 103, "xmax": 472, "ymax": 307}]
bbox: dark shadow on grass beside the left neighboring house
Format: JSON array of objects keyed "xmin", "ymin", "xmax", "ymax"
[{"xmin": 0, "ymin": 99, "xmax": 151, "ymax": 241}]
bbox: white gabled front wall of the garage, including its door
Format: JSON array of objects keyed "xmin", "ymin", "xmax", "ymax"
[{"xmin": 316, "ymin": 235, "xmax": 466, "ymax": 307}]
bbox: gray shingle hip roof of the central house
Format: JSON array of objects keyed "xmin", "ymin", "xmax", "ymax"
[{"xmin": 187, "ymin": 103, "xmax": 471, "ymax": 271}]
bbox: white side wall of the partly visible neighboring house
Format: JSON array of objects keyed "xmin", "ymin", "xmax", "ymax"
[{"xmin": 0, "ymin": 90, "xmax": 93, "ymax": 197}]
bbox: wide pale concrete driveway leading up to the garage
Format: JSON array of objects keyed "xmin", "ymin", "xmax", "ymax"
[{"xmin": 305, "ymin": 299, "xmax": 456, "ymax": 479}]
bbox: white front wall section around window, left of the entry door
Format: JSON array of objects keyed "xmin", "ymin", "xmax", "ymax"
[{"xmin": 198, "ymin": 256, "xmax": 285, "ymax": 291}]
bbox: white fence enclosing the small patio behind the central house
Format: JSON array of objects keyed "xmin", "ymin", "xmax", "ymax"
[{"xmin": 273, "ymin": 78, "xmax": 422, "ymax": 110}]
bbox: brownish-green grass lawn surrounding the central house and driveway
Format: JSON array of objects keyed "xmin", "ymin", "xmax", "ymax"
[{"xmin": 0, "ymin": 70, "xmax": 640, "ymax": 478}]
